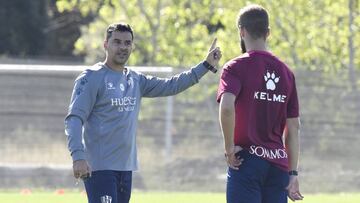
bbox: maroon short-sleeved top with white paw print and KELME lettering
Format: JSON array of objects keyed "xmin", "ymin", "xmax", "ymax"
[{"xmin": 217, "ymin": 51, "xmax": 299, "ymax": 171}]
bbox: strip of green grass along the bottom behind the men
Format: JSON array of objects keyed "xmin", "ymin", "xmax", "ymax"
[{"xmin": 0, "ymin": 192, "xmax": 360, "ymax": 203}]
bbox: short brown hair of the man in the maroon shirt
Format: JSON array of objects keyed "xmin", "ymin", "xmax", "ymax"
[{"xmin": 237, "ymin": 4, "xmax": 269, "ymax": 39}]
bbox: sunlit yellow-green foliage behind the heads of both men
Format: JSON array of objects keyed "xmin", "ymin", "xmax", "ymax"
[{"xmin": 57, "ymin": 0, "xmax": 360, "ymax": 72}]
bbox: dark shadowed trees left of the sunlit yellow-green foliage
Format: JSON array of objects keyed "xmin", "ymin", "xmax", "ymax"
[{"xmin": 0, "ymin": 0, "xmax": 95, "ymax": 60}]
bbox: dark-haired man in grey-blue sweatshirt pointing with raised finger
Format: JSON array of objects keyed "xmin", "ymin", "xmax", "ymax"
[{"xmin": 65, "ymin": 23, "xmax": 221, "ymax": 203}]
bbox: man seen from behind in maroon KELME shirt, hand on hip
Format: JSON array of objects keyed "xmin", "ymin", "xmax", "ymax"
[{"xmin": 217, "ymin": 5, "xmax": 303, "ymax": 203}]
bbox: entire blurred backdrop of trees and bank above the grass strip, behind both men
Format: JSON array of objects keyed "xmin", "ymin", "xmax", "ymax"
[{"xmin": 0, "ymin": 0, "xmax": 360, "ymax": 193}]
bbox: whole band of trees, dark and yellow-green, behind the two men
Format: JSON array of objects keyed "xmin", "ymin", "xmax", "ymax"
[{"xmin": 0, "ymin": 0, "xmax": 360, "ymax": 70}]
